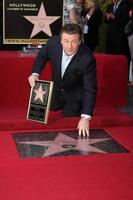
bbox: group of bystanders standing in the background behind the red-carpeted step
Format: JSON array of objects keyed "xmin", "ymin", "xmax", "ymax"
[{"xmin": 64, "ymin": 0, "xmax": 133, "ymax": 86}]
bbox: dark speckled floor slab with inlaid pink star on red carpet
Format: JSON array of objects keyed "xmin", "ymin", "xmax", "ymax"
[{"xmin": 12, "ymin": 130, "xmax": 128, "ymax": 157}]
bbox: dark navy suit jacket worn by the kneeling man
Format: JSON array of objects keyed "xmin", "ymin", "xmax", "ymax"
[{"xmin": 32, "ymin": 36, "xmax": 97, "ymax": 116}]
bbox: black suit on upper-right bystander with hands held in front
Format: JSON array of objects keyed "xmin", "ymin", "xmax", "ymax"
[{"xmin": 105, "ymin": 0, "xmax": 129, "ymax": 57}]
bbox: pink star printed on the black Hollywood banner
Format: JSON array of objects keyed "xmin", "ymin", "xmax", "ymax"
[{"xmin": 23, "ymin": 3, "xmax": 61, "ymax": 38}]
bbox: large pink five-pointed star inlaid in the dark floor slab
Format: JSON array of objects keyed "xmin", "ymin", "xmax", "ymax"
[{"xmin": 17, "ymin": 133, "xmax": 108, "ymax": 157}]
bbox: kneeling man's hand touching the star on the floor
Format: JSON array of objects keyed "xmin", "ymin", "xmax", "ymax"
[{"xmin": 77, "ymin": 117, "xmax": 89, "ymax": 137}]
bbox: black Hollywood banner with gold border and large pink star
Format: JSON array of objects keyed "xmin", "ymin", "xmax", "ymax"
[{"xmin": 3, "ymin": 0, "xmax": 63, "ymax": 44}]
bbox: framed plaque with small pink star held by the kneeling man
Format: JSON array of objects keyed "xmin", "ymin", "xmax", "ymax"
[{"xmin": 27, "ymin": 80, "xmax": 54, "ymax": 124}]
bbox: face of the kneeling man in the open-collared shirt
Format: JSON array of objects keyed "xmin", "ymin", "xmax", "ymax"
[{"xmin": 61, "ymin": 33, "xmax": 81, "ymax": 56}]
